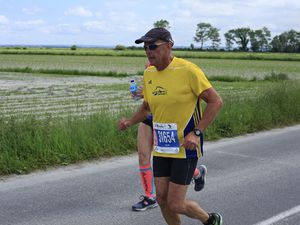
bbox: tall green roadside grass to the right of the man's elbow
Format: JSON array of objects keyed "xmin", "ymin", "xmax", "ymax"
[{"xmin": 206, "ymin": 81, "xmax": 300, "ymax": 139}]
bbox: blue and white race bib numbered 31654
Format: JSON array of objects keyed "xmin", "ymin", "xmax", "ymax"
[{"xmin": 153, "ymin": 122, "xmax": 180, "ymax": 154}]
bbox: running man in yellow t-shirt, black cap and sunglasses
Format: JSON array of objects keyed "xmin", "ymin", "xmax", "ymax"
[{"xmin": 118, "ymin": 28, "xmax": 223, "ymax": 225}]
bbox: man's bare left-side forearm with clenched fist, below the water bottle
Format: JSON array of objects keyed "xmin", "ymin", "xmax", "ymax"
[{"xmin": 118, "ymin": 101, "xmax": 150, "ymax": 130}]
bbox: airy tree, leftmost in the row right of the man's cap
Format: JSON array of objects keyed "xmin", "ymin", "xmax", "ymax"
[{"xmin": 194, "ymin": 23, "xmax": 221, "ymax": 49}]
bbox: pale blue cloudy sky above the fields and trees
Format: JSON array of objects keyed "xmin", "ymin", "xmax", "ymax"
[{"xmin": 0, "ymin": 0, "xmax": 300, "ymax": 46}]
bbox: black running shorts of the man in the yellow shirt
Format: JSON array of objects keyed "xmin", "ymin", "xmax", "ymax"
[{"xmin": 153, "ymin": 156, "xmax": 198, "ymax": 185}]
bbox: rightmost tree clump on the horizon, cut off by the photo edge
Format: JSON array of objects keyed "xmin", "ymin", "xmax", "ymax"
[{"xmin": 271, "ymin": 29, "xmax": 300, "ymax": 52}]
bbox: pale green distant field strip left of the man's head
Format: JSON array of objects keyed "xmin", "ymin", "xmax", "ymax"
[{"xmin": 0, "ymin": 54, "xmax": 146, "ymax": 74}]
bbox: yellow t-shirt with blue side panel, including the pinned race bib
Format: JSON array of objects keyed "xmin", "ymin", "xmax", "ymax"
[{"xmin": 143, "ymin": 57, "xmax": 211, "ymax": 158}]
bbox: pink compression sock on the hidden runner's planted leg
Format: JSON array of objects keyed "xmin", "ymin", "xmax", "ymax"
[{"xmin": 140, "ymin": 164, "xmax": 155, "ymax": 198}]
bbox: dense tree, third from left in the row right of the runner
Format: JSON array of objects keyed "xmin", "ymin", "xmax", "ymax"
[{"xmin": 250, "ymin": 27, "xmax": 271, "ymax": 52}]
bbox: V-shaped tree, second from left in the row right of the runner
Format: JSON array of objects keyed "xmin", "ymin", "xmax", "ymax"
[{"xmin": 227, "ymin": 27, "xmax": 251, "ymax": 52}]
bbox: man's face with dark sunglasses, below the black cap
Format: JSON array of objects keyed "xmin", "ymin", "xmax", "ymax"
[{"xmin": 144, "ymin": 40, "xmax": 170, "ymax": 66}]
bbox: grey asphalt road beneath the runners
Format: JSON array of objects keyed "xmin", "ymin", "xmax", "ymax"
[{"xmin": 0, "ymin": 125, "xmax": 300, "ymax": 225}]
